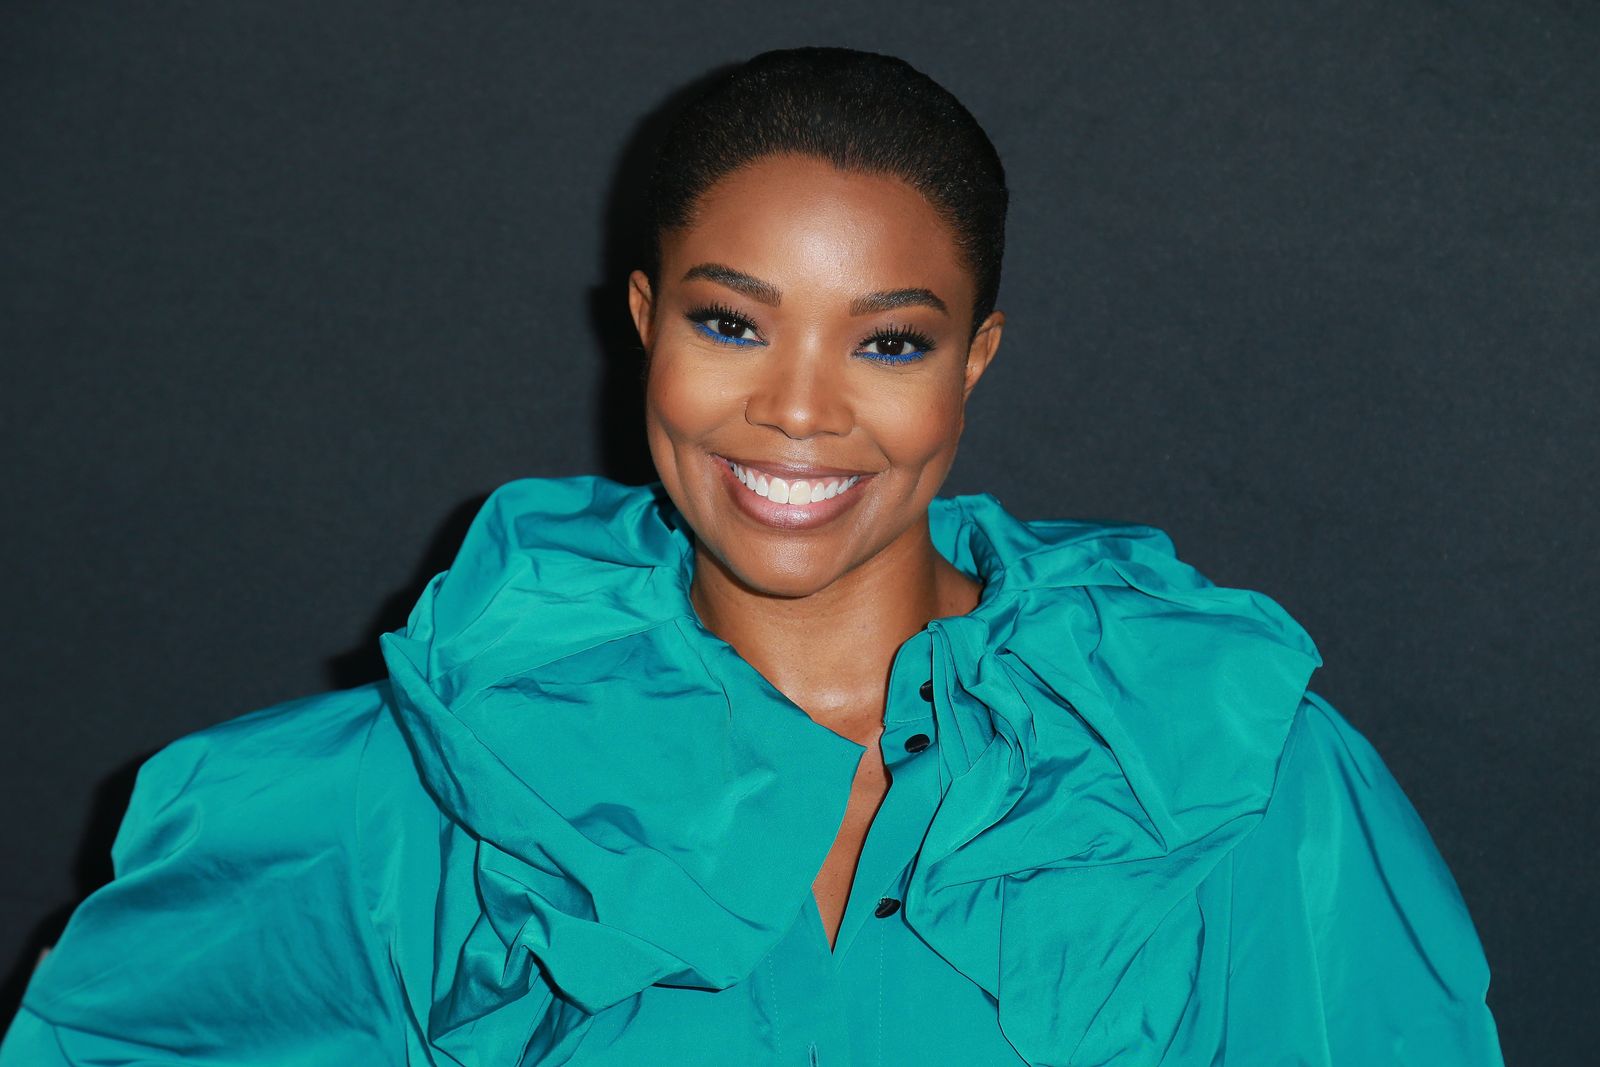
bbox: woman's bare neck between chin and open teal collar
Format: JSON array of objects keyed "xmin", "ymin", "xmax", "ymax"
[{"xmin": 690, "ymin": 522, "xmax": 982, "ymax": 741}]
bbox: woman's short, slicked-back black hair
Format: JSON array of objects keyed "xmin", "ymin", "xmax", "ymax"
[{"xmin": 650, "ymin": 48, "xmax": 1008, "ymax": 330}]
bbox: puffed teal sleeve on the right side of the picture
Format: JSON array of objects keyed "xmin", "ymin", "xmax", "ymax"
[{"xmin": 1227, "ymin": 694, "xmax": 1502, "ymax": 1067}]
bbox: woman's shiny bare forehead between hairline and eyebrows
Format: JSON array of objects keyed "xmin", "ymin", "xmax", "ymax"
[{"xmin": 662, "ymin": 155, "xmax": 973, "ymax": 307}]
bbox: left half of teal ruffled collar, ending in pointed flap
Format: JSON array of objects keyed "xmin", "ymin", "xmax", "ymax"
[{"xmin": 384, "ymin": 478, "xmax": 862, "ymax": 1064}]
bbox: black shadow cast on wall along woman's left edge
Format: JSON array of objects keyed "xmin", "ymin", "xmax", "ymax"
[{"xmin": 0, "ymin": 67, "xmax": 731, "ymax": 1032}]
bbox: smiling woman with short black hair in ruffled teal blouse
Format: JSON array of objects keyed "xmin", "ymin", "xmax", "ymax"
[{"xmin": 0, "ymin": 50, "xmax": 1499, "ymax": 1067}]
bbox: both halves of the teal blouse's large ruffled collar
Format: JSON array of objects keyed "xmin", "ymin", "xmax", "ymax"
[{"xmin": 382, "ymin": 478, "xmax": 1320, "ymax": 1064}]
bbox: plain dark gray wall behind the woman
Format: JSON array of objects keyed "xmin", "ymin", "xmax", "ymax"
[{"xmin": 0, "ymin": 0, "xmax": 1600, "ymax": 1064}]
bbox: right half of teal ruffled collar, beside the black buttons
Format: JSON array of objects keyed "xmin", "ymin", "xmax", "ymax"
[{"xmin": 906, "ymin": 496, "xmax": 1322, "ymax": 1064}]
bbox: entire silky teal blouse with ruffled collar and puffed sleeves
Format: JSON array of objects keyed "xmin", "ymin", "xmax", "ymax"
[{"xmin": 0, "ymin": 478, "xmax": 1501, "ymax": 1067}]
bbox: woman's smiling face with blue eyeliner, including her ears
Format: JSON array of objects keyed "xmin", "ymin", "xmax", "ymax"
[{"xmin": 629, "ymin": 155, "xmax": 1003, "ymax": 597}]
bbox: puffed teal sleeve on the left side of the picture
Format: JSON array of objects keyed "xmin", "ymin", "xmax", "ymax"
[{"xmin": 0, "ymin": 696, "xmax": 403, "ymax": 1067}]
